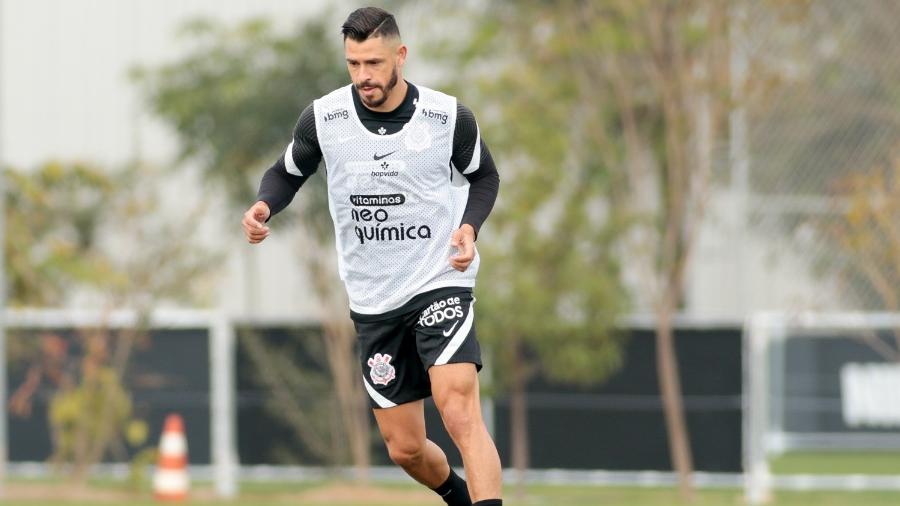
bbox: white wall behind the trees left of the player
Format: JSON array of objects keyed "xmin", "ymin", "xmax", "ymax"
[{"xmin": 0, "ymin": 0, "xmax": 346, "ymax": 317}]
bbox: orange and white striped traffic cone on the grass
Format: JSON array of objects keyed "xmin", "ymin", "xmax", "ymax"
[{"xmin": 153, "ymin": 414, "xmax": 190, "ymax": 501}]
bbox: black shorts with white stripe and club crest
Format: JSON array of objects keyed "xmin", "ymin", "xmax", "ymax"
[{"xmin": 351, "ymin": 287, "xmax": 481, "ymax": 408}]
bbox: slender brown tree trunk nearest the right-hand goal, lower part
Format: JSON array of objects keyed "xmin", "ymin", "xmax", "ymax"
[{"xmin": 656, "ymin": 286, "xmax": 694, "ymax": 502}]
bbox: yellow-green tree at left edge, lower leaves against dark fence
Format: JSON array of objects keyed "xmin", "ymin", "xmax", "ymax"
[{"xmin": 4, "ymin": 162, "xmax": 211, "ymax": 484}]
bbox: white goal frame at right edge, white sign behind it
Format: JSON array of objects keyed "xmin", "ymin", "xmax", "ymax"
[{"xmin": 743, "ymin": 313, "xmax": 900, "ymax": 504}]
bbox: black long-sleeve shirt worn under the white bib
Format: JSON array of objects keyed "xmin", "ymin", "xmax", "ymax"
[{"xmin": 257, "ymin": 83, "xmax": 500, "ymax": 235}]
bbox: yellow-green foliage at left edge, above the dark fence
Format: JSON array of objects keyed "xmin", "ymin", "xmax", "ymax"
[{"xmin": 4, "ymin": 162, "xmax": 214, "ymax": 307}]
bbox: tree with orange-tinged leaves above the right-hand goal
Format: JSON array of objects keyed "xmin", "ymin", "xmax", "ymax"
[{"xmin": 748, "ymin": 0, "xmax": 900, "ymax": 314}]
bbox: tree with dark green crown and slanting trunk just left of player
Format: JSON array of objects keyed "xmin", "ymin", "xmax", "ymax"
[{"xmin": 135, "ymin": 15, "xmax": 370, "ymax": 478}]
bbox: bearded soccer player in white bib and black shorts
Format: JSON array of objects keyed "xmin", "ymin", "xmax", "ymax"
[{"xmin": 242, "ymin": 7, "xmax": 502, "ymax": 506}]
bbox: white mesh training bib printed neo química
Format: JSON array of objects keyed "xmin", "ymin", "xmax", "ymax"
[{"xmin": 314, "ymin": 85, "xmax": 480, "ymax": 314}]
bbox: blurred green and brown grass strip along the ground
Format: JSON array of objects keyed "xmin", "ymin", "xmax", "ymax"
[{"xmin": 7, "ymin": 452, "xmax": 900, "ymax": 506}]
